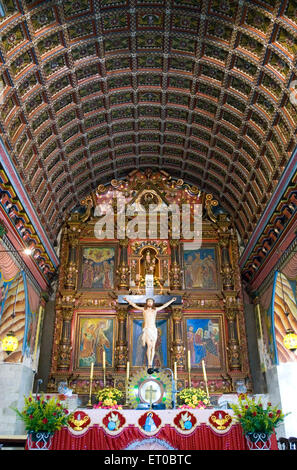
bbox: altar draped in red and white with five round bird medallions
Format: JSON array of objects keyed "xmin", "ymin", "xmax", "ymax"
[{"xmin": 48, "ymin": 409, "xmax": 278, "ymax": 451}]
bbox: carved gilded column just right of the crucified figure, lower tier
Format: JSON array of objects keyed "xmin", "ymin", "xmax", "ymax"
[{"xmin": 171, "ymin": 305, "xmax": 185, "ymax": 372}]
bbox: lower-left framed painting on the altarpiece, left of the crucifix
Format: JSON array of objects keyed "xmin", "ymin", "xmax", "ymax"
[{"xmin": 76, "ymin": 315, "xmax": 115, "ymax": 368}]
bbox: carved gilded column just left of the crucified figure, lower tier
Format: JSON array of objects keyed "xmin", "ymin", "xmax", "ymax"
[{"xmin": 115, "ymin": 305, "xmax": 129, "ymax": 370}]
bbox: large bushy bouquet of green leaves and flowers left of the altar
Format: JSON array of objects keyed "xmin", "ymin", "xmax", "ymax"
[{"xmin": 14, "ymin": 394, "xmax": 69, "ymax": 432}]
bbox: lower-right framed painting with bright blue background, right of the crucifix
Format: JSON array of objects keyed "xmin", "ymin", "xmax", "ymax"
[{"xmin": 185, "ymin": 316, "xmax": 224, "ymax": 370}]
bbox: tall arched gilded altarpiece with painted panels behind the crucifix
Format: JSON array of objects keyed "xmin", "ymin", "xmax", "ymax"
[{"xmin": 48, "ymin": 170, "xmax": 251, "ymax": 402}]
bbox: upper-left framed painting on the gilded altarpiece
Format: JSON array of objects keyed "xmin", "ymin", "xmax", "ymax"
[{"xmin": 80, "ymin": 244, "xmax": 117, "ymax": 290}]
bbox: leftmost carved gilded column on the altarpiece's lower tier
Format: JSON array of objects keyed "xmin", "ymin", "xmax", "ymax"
[{"xmin": 58, "ymin": 293, "xmax": 75, "ymax": 370}]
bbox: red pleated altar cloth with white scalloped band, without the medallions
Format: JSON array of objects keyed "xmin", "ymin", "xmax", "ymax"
[{"xmin": 44, "ymin": 410, "xmax": 278, "ymax": 451}]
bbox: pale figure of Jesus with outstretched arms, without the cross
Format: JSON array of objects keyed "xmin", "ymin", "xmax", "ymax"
[{"xmin": 124, "ymin": 297, "xmax": 176, "ymax": 367}]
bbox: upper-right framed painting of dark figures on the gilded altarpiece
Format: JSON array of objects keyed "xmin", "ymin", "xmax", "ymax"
[{"xmin": 183, "ymin": 243, "xmax": 218, "ymax": 290}]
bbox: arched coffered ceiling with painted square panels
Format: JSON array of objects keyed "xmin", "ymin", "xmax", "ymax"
[{"xmin": 0, "ymin": 0, "xmax": 297, "ymax": 258}]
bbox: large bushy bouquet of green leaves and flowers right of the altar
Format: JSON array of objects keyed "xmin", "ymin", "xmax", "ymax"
[{"xmin": 230, "ymin": 395, "xmax": 286, "ymax": 435}]
